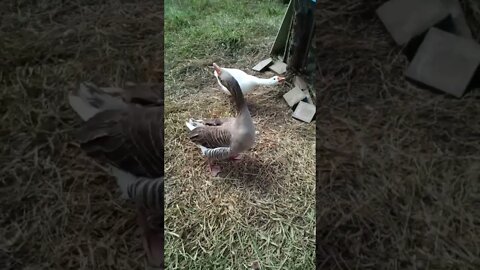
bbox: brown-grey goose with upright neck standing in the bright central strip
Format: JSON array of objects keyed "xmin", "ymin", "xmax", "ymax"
[{"xmin": 186, "ymin": 68, "xmax": 255, "ymax": 176}]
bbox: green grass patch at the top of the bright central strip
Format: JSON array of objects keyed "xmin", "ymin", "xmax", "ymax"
[{"xmin": 165, "ymin": 1, "xmax": 286, "ymax": 94}]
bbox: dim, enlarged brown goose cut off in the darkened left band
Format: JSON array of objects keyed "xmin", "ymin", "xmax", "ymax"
[{"xmin": 69, "ymin": 83, "xmax": 164, "ymax": 269}]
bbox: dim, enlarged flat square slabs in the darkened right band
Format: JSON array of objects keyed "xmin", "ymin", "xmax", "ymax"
[{"xmin": 377, "ymin": 0, "xmax": 480, "ymax": 97}]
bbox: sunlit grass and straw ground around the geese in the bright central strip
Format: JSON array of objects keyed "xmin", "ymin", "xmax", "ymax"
[{"xmin": 165, "ymin": 0, "xmax": 315, "ymax": 270}]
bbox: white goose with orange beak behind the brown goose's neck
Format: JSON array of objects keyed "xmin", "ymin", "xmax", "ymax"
[{"xmin": 213, "ymin": 63, "xmax": 285, "ymax": 95}]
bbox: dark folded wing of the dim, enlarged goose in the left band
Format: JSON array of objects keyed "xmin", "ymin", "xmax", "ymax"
[{"xmin": 77, "ymin": 106, "xmax": 164, "ymax": 178}]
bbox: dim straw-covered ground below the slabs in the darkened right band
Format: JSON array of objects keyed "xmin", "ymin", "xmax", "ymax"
[{"xmin": 316, "ymin": 0, "xmax": 480, "ymax": 269}]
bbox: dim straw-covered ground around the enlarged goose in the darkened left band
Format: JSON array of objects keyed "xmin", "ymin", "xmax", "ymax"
[{"xmin": 0, "ymin": 0, "xmax": 163, "ymax": 269}]
